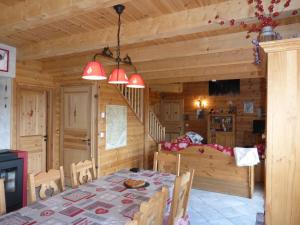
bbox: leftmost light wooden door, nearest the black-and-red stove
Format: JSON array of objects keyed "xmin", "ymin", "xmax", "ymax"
[{"xmin": 17, "ymin": 88, "xmax": 47, "ymax": 174}]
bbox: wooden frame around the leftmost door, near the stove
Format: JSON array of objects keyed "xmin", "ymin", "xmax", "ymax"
[{"xmin": 13, "ymin": 82, "xmax": 54, "ymax": 171}]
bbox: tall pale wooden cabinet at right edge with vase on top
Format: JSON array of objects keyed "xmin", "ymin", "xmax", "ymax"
[{"xmin": 261, "ymin": 38, "xmax": 300, "ymax": 225}]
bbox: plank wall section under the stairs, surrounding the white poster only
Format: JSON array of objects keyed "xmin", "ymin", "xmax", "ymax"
[{"xmin": 98, "ymin": 83, "xmax": 144, "ymax": 175}]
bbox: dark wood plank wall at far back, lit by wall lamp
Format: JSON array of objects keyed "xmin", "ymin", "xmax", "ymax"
[{"xmin": 158, "ymin": 78, "xmax": 266, "ymax": 146}]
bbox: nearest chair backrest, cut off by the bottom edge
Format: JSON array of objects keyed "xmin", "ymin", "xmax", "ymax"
[{"xmin": 134, "ymin": 187, "xmax": 169, "ymax": 225}]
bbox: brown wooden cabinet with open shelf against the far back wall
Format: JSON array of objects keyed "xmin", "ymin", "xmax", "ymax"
[{"xmin": 207, "ymin": 114, "xmax": 235, "ymax": 147}]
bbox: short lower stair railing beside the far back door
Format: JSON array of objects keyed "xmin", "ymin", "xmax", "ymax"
[{"xmin": 149, "ymin": 110, "xmax": 166, "ymax": 143}]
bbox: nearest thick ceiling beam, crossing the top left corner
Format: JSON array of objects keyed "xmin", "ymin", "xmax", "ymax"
[{"xmin": 0, "ymin": 0, "xmax": 129, "ymax": 35}]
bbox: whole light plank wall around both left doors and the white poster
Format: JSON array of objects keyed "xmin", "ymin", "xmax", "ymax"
[{"xmin": 12, "ymin": 61, "xmax": 144, "ymax": 175}]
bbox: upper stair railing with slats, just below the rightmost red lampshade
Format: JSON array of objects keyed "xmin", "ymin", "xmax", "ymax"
[{"xmin": 117, "ymin": 84, "xmax": 144, "ymax": 122}]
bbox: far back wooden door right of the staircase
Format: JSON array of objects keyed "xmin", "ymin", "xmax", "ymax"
[{"xmin": 162, "ymin": 99, "xmax": 184, "ymax": 141}]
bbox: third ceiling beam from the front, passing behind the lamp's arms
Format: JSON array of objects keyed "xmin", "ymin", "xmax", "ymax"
[{"xmin": 44, "ymin": 23, "xmax": 300, "ymax": 72}]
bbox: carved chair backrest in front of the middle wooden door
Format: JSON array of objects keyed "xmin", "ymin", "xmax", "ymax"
[{"xmin": 71, "ymin": 158, "xmax": 96, "ymax": 188}]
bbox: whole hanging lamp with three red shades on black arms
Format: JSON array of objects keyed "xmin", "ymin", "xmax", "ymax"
[{"xmin": 82, "ymin": 4, "xmax": 145, "ymax": 88}]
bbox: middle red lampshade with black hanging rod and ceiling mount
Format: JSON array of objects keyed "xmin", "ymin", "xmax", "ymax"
[{"xmin": 108, "ymin": 5, "xmax": 128, "ymax": 84}]
